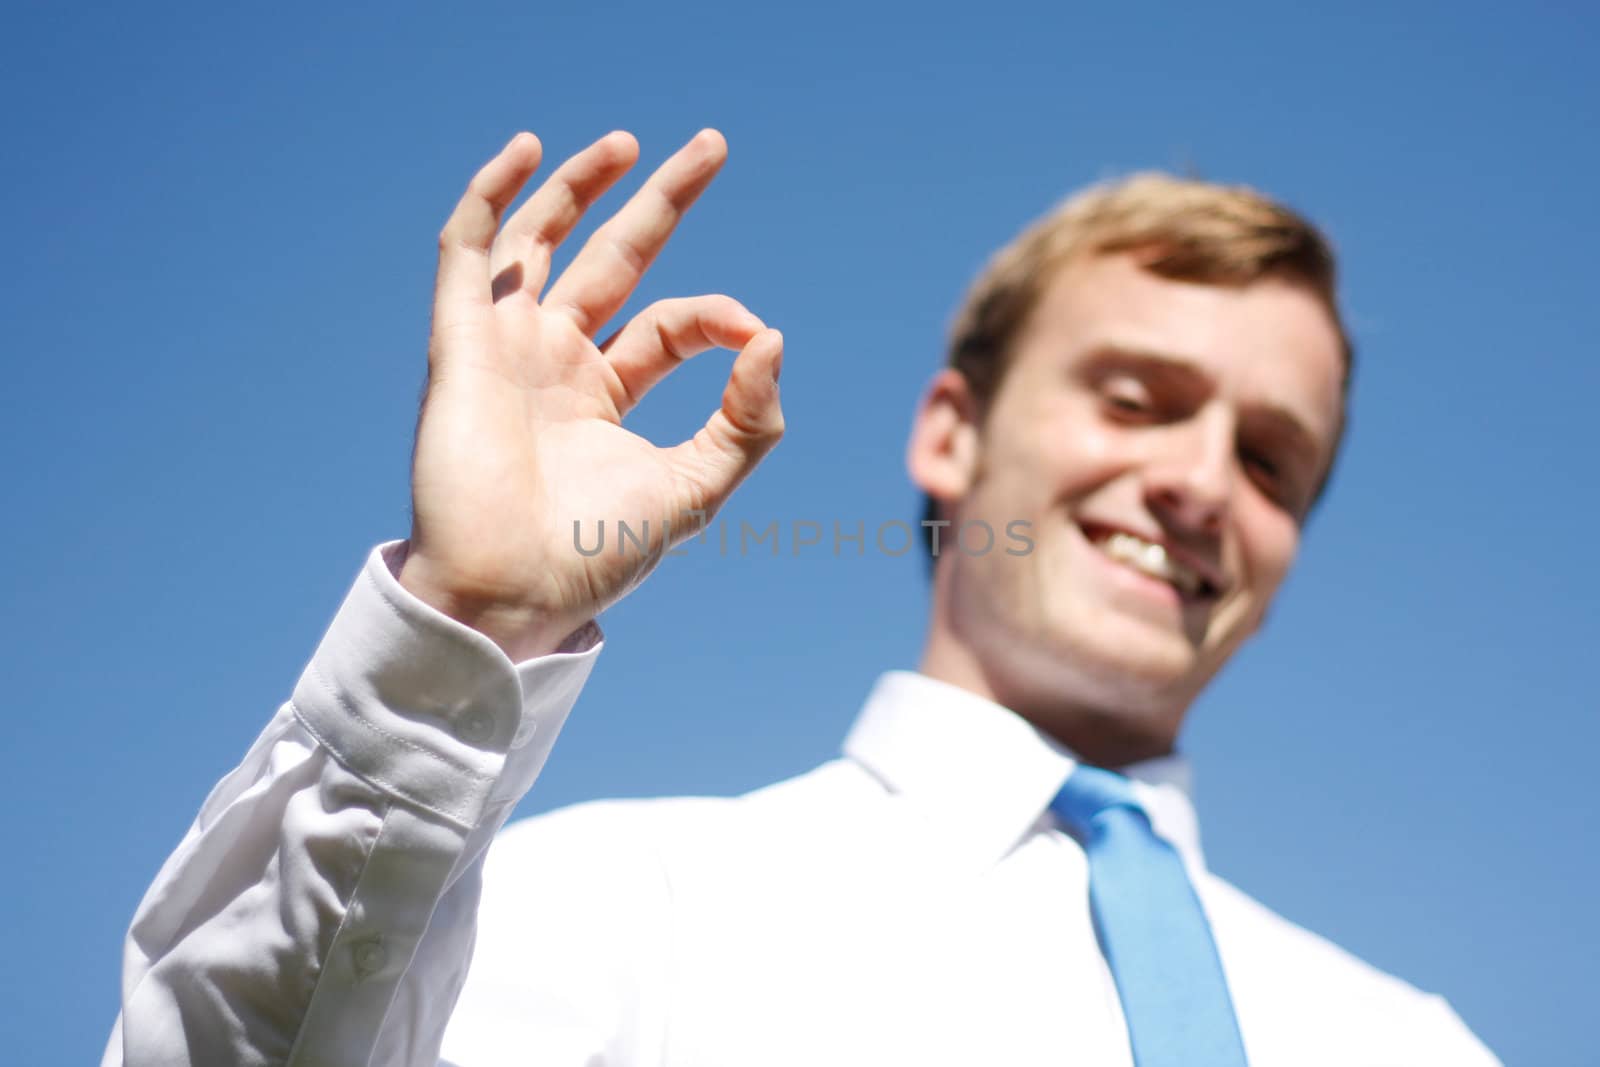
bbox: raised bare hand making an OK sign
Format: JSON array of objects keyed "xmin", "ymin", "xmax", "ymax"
[{"xmin": 400, "ymin": 130, "xmax": 784, "ymax": 659}]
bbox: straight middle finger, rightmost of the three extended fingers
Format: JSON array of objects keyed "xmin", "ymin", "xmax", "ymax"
[{"xmin": 544, "ymin": 130, "xmax": 728, "ymax": 336}]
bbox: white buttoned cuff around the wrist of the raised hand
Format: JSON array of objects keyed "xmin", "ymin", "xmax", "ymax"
[{"xmin": 291, "ymin": 541, "xmax": 605, "ymax": 830}]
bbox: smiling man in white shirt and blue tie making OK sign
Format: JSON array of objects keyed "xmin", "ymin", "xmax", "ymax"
[{"xmin": 106, "ymin": 131, "xmax": 1494, "ymax": 1067}]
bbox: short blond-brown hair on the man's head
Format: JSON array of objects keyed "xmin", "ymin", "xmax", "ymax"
[{"xmin": 923, "ymin": 173, "xmax": 1354, "ymax": 559}]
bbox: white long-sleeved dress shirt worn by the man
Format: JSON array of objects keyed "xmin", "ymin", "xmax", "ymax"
[{"xmin": 104, "ymin": 545, "xmax": 1498, "ymax": 1067}]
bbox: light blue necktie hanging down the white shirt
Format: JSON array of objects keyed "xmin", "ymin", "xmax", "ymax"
[{"xmin": 1050, "ymin": 765, "xmax": 1245, "ymax": 1067}]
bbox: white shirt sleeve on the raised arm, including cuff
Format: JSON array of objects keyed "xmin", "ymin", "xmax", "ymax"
[{"xmin": 102, "ymin": 542, "xmax": 602, "ymax": 1067}]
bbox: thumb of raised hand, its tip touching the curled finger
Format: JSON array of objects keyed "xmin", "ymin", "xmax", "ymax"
[{"xmin": 667, "ymin": 330, "xmax": 784, "ymax": 518}]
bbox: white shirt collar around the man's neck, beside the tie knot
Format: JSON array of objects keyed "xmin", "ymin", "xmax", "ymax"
[{"xmin": 845, "ymin": 670, "xmax": 1205, "ymax": 870}]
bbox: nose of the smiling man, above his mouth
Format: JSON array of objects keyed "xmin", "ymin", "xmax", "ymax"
[{"xmin": 1144, "ymin": 413, "xmax": 1234, "ymax": 536}]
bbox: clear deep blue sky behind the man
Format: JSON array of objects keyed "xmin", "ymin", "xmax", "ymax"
[{"xmin": 0, "ymin": 3, "xmax": 1600, "ymax": 1065}]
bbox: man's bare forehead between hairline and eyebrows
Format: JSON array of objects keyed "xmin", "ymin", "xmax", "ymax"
[{"xmin": 1013, "ymin": 254, "xmax": 1344, "ymax": 442}]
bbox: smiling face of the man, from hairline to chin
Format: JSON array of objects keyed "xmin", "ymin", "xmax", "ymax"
[{"xmin": 941, "ymin": 254, "xmax": 1342, "ymax": 731}]
